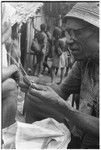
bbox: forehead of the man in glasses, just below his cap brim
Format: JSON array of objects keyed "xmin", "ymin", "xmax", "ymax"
[{"xmin": 64, "ymin": 18, "xmax": 86, "ymax": 30}]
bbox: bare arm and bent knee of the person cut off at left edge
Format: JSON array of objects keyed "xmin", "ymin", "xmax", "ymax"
[{"xmin": 2, "ymin": 65, "xmax": 18, "ymax": 128}]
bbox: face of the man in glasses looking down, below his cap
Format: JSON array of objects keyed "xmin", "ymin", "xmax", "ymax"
[{"xmin": 66, "ymin": 19, "xmax": 99, "ymax": 60}]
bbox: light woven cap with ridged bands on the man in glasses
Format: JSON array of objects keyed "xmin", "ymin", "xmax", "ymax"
[{"xmin": 63, "ymin": 2, "xmax": 99, "ymax": 27}]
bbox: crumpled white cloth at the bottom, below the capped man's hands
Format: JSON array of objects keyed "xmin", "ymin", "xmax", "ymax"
[{"xmin": 2, "ymin": 118, "xmax": 71, "ymax": 149}]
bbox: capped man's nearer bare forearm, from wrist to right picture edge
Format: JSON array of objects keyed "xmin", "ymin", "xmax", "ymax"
[{"xmin": 62, "ymin": 103, "xmax": 99, "ymax": 137}]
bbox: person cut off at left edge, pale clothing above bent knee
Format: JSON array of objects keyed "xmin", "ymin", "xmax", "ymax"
[{"xmin": 1, "ymin": 2, "xmax": 18, "ymax": 128}]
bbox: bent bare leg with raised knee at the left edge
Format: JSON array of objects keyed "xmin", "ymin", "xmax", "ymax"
[{"xmin": 2, "ymin": 78, "xmax": 18, "ymax": 128}]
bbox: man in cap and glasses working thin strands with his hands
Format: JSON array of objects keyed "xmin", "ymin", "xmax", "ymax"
[{"xmin": 20, "ymin": 2, "xmax": 99, "ymax": 149}]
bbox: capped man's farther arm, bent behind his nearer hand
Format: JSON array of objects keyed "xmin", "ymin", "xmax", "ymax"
[{"xmin": 51, "ymin": 62, "xmax": 81, "ymax": 100}]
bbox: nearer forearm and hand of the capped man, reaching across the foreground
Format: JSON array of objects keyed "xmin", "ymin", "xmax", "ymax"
[{"xmin": 23, "ymin": 81, "xmax": 99, "ymax": 137}]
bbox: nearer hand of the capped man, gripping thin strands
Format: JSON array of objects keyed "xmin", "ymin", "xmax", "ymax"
[{"xmin": 27, "ymin": 84, "xmax": 66, "ymax": 122}]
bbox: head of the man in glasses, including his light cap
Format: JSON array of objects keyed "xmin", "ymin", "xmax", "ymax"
[{"xmin": 64, "ymin": 2, "xmax": 99, "ymax": 60}]
